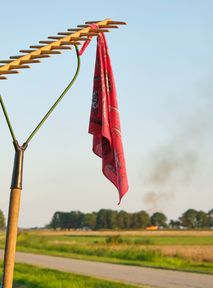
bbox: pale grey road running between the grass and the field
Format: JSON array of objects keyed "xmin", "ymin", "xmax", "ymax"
[{"xmin": 0, "ymin": 250, "xmax": 213, "ymax": 288}]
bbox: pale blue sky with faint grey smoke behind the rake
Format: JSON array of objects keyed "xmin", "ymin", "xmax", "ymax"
[{"xmin": 0, "ymin": 0, "xmax": 213, "ymax": 227}]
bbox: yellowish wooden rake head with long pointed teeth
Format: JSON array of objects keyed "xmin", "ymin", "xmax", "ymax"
[{"xmin": 0, "ymin": 19, "xmax": 126, "ymax": 80}]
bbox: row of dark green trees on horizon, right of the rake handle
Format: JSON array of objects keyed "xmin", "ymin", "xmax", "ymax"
[{"xmin": 48, "ymin": 209, "xmax": 213, "ymax": 230}]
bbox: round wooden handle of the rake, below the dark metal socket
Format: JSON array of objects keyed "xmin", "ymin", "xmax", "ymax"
[{"xmin": 2, "ymin": 189, "xmax": 21, "ymax": 288}]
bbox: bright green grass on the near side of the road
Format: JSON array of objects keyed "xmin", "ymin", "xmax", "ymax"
[{"xmin": 1, "ymin": 263, "xmax": 145, "ymax": 288}]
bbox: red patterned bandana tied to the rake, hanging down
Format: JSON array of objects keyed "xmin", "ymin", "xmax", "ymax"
[{"xmin": 79, "ymin": 33, "xmax": 128, "ymax": 203}]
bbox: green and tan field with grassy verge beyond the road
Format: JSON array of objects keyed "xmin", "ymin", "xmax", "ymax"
[{"xmin": 0, "ymin": 230, "xmax": 213, "ymax": 274}]
